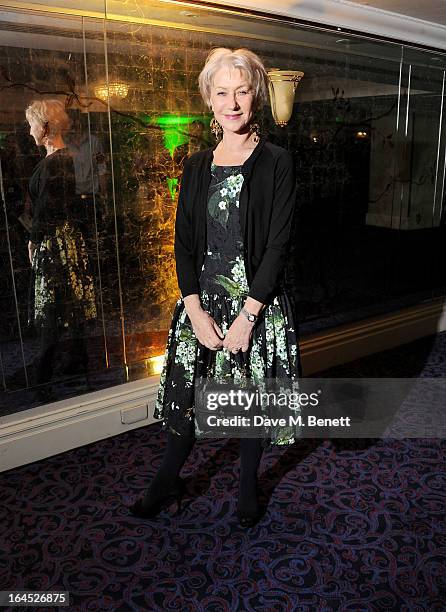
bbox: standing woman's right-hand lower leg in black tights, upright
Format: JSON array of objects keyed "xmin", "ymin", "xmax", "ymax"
[{"xmin": 237, "ymin": 438, "xmax": 263, "ymax": 516}]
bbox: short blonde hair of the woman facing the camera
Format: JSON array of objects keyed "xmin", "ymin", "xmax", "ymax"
[{"xmin": 198, "ymin": 47, "xmax": 268, "ymax": 109}]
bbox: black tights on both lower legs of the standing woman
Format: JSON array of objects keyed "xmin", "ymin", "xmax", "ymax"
[{"xmin": 143, "ymin": 431, "xmax": 263, "ymax": 512}]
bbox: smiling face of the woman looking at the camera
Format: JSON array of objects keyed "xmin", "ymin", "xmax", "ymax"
[{"xmin": 210, "ymin": 67, "xmax": 254, "ymax": 133}]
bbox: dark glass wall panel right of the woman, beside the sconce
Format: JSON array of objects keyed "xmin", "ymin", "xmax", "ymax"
[{"xmin": 272, "ymin": 34, "xmax": 412, "ymax": 333}]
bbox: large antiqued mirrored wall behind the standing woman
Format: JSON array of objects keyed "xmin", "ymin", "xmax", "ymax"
[{"xmin": 0, "ymin": 2, "xmax": 446, "ymax": 414}]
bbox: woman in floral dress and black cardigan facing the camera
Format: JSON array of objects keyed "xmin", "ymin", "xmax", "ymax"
[{"xmin": 131, "ymin": 48, "xmax": 301, "ymax": 526}]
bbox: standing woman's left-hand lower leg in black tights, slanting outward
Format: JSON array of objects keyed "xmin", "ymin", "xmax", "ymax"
[{"xmin": 142, "ymin": 431, "xmax": 195, "ymax": 507}]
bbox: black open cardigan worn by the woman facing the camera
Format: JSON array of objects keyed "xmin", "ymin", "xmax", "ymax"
[{"xmin": 175, "ymin": 137, "xmax": 296, "ymax": 304}]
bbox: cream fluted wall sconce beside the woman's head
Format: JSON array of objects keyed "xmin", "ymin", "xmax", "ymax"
[{"xmin": 268, "ymin": 68, "xmax": 305, "ymax": 127}]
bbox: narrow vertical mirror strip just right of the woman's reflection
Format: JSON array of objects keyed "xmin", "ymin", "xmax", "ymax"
[{"xmin": 77, "ymin": 18, "xmax": 128, "ymax": 388}]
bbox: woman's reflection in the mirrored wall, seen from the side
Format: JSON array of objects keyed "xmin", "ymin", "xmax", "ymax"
[{"xmin": 26, "ymin": 99, "xmax": 96, "ymax": 399}]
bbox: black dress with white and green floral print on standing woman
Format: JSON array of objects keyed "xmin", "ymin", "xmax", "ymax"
[{"xmin": 154, "ymin": 162, "xmax": 302, "ymax": 447}]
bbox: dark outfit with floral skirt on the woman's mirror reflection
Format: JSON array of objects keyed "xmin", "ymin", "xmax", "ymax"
[{"xmin": 28, "ymin": 148, "xmax": 97, "ymax": 336}]
